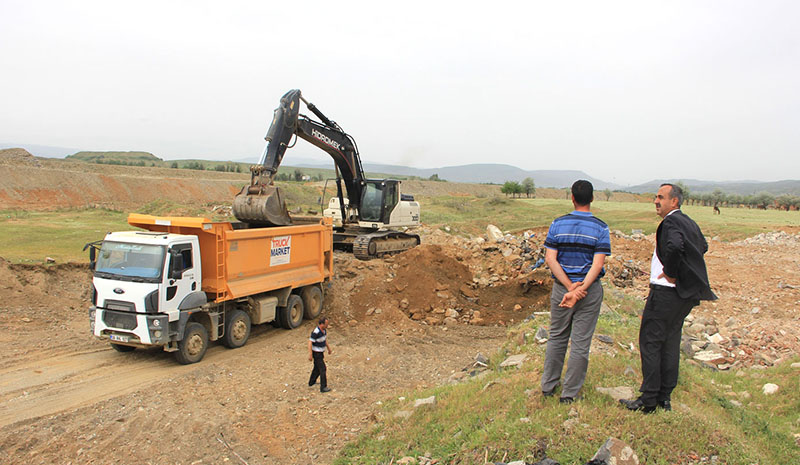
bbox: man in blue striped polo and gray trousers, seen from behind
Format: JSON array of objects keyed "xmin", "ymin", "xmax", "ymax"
[{"xmin": 542, "ymin": 180, "xmax": 611, "ymax": 403}]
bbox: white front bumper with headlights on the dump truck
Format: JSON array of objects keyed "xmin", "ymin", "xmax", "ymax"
[{"xmin": 89, "ymin": 306, "xmax": 170, "ymax": 347}]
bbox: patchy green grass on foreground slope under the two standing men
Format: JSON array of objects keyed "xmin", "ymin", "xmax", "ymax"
[{"xmin": 334, "ymin": 293, "xmax": 800, "ymax": 465}]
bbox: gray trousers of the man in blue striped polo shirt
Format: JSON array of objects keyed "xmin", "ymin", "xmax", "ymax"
[{"xmin": 542, "ymin": 280, "xmax": 603, "ymax": 397}]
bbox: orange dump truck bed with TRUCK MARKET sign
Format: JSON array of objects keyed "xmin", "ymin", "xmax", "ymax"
[{"xmin": 128, "ymin": 213, "xmax": 333, "ymax": 302}]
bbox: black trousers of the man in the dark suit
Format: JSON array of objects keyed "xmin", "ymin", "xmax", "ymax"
[{"xmin": 639, "ymin": 286, "xmax": 699, "ymax": 406}]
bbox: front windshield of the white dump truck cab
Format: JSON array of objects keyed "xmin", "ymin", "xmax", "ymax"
[{"xmin": 95, "ymin": 242, "xmax": 164, "ymax": 280}]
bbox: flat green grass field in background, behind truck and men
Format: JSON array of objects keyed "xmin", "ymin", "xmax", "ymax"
[{"xmin": 0, "ymin": 194, "xmax": 800, "ymax": 263}]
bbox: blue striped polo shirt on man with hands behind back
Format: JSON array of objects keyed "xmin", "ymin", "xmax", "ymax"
[{"xmin": 544, "ymin": 210, "xmax": 611, "ymax": 283}]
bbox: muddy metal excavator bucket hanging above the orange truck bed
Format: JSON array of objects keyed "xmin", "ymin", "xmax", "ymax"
[{"xmin": 233, "ymin": 185, "xmax": 292, "ymax": 226}]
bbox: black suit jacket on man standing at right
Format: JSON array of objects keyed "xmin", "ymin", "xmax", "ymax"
[{"xmin": 656, "ymin": 210, "xmax": 717, "ymax": 300}]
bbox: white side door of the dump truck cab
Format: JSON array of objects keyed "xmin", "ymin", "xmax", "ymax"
[{"xmin": 161, "ymin": 243, "xmax": 200, "ymax": 321}]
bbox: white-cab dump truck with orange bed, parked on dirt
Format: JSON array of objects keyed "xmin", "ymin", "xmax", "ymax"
[{"xmin": 86, "ymin": 214, "xmax": 333, "ymax": 364}]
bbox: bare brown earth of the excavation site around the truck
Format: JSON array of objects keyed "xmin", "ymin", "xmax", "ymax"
[{"xmin": 0, "ymin": 153, "xmax": 800, "ymax": 464}]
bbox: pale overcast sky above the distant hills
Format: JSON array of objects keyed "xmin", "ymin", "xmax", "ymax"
[{"xmin": 0, "ymin": 0, "xmax": 800, "ymax": 185}]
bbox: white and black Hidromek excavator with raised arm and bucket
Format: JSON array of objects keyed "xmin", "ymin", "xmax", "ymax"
[{"xmin": 233, "ymin": 89, "xmax": 420, "ymax": 260}]
